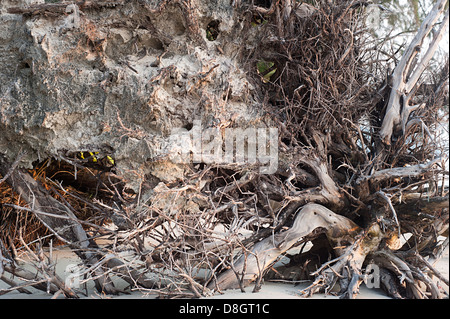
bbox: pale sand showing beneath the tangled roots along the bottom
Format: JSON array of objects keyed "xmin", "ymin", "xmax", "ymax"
[{"xmin": 0, "ymin": 248, "xmax": 449, "ymax": 300}]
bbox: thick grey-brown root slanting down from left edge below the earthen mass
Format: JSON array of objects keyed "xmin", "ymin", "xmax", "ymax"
[{"xmin": 0, "ymin": 160, "xmax": 158, "ymax": 297}]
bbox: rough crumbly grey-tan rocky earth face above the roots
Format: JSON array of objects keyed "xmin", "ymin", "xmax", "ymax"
[{"xmin": 0, "ymin": 0, "xmax": 264, "ymax": 189}]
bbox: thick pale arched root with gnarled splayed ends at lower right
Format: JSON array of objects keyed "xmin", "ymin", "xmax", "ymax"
[{"xmin": 208, "ymin": 201, "xmax": 448, "ymax": 298}]
